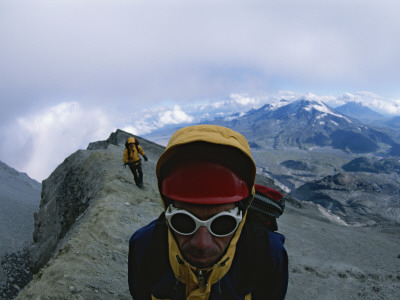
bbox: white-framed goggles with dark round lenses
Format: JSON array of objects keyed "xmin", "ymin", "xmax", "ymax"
[{"xmin": 165, "ymin": 204, "xmax": 243, "ymax": 237}]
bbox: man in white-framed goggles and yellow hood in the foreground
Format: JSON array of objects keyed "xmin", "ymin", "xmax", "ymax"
[{"xmin": 128, "ymin": 125, "xmax": 288, "ymax": 300}]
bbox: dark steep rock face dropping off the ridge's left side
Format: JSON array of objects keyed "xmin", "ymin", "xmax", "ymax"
[{"xmin": 29, "ymin": 150, "xmax": 104, "ymax": 273}]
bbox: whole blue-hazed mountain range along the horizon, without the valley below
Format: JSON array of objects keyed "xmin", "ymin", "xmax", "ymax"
[{"xmin": 143, "ymin": 99, "xmax": 400, "ymax": 156}]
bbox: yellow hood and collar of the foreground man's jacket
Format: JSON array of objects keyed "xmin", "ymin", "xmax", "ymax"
[{"xmin": 153, "ymin": 125, "xmax": 256, "ymax": 300}]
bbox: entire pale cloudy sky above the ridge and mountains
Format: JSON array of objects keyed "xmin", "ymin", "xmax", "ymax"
[{"xmin": 0, "ymin": 0, "xmax": 400, "ymax": 181}]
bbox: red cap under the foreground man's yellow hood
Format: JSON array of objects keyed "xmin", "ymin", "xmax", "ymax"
[{"xmin": 161, "ymin": 161, "xmax": 249, "ymax": 204}]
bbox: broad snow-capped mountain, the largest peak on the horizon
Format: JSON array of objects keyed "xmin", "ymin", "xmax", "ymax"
[{"xmin": 210, "ymin": 99, "xmax": 396, "ymax": 153}]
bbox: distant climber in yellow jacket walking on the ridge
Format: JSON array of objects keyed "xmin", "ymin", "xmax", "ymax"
[{"xmin": 123, "ymin": 137, "xmax": 147, "ymax": 187}]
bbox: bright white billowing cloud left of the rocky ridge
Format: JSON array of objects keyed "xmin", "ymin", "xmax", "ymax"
[{"xmin": 12, "ymin": 102, "xmax": 113, "ymax": 181}]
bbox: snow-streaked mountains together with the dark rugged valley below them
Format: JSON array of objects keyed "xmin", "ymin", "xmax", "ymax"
[{"xmin": 145, "ymin": 99, "xmax": 400, "ymax": 225}]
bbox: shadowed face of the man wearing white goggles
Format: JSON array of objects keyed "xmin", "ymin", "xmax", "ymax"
[{"xmin": 172, "ymin": 201, "xmax": 235, "ymax": 268}]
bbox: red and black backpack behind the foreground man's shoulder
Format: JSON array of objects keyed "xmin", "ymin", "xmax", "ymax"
[{"xmin": 248, "ymin": 184, "xmax": 285, "ymax": 231}]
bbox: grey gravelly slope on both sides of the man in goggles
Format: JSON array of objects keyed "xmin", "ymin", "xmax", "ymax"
[{"xmin": 17, "ymin": 137, "xmax": 400, "ymax": 300}]
